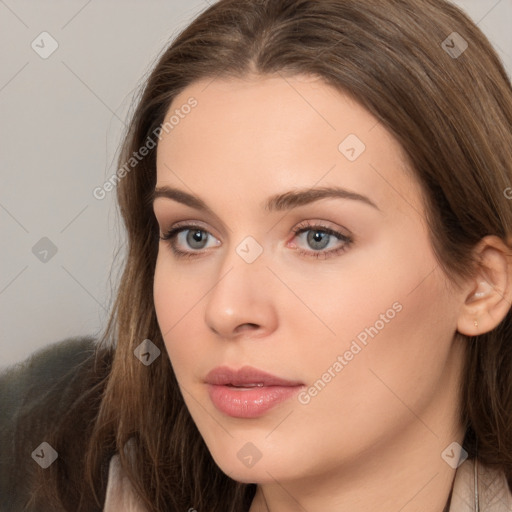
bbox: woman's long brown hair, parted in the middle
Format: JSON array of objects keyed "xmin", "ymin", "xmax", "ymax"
[{"xmin": 31, "ymin": 0, "xmax": 512, "ymax": 512}]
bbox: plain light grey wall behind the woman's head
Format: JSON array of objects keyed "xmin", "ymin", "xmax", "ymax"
[{"xmin": 0, "ymin": 0, "xmax": 512, "ymax": 366}]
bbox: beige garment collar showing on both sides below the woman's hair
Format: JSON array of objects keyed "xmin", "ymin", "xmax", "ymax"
[{"xmin": 103, "ymin": 455, "xmax": 512, "ymax": 512}]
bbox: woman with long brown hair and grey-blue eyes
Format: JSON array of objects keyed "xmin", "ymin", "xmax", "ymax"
[{"xmin": 7, "ymin": 0, "xmax": 512, "ymax": 512}]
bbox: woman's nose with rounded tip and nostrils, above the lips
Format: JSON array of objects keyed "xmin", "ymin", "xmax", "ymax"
[{"xmin": 205, "ymin": 250, "xmax": 278, "ymax": 339}]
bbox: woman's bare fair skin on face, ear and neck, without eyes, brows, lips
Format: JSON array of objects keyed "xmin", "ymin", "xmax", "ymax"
[{"xmin": 154, "ymin": 76, "xmax": 510, "ymax": 512}]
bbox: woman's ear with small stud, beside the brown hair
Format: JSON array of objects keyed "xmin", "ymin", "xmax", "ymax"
[{"xmin": 457, "ymin": 236, "xmax": 512, "ymax": 336}]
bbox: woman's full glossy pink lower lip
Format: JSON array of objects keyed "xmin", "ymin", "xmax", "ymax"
[{"xmin": 208, "ymin": 384, "xmax": 302, "ymax": 418}]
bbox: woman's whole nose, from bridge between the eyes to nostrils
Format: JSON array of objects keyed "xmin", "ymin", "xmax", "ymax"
[{"xmin": 205, "ymin": 237, "xmax": 277, "ymax": 338}]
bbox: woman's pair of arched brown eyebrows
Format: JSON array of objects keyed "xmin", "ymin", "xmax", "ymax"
[{"xmin": 151, "ymin": 186, "xmax": 380, "ymax": 215}]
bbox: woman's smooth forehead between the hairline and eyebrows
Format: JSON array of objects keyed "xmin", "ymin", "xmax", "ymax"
[{"xmin": 157, "ymin": 75, "xmax": 421, "ymax": 216}]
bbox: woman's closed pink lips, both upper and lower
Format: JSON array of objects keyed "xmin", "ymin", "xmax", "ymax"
[{"xmin": 205, "ymin": 366, "xmax": 304, "ymax": 418}]
